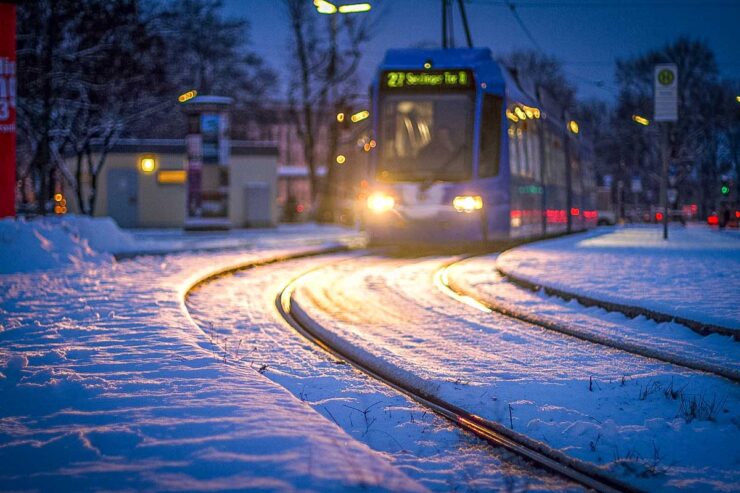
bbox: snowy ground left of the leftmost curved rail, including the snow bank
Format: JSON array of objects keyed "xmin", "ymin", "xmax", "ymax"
[{"xmin": 0, "ymin": 219, "xmax": 434, "ymax": 491}]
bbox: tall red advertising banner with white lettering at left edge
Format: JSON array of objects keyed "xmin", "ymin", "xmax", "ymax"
[{"xmin": 0, "ymin": 2, "xmax": 16, "ymax": 217}]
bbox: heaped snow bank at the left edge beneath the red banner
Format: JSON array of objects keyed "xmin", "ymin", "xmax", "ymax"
[{"xmin": 0, "ymin": 215, "xmax": 134, "ymax": 274}]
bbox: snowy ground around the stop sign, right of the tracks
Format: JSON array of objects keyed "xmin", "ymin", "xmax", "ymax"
[{"xmin": 497, "ymin": 226, "xmax": 740, "ymax": 330}]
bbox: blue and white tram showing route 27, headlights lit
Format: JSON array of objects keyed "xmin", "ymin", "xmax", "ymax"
[{"xmin": 366, "ymin": 48, "xmax": 596, "ymax": 243}]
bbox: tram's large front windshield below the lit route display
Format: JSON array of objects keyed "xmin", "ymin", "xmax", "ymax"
[{"xmin": 377, "ymin": 94, "xmax": 473, "ymax": 181}]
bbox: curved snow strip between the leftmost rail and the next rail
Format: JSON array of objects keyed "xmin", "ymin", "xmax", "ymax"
[{"xmin": 187, "ymin": 255, "xmax": 573, "ymax": 491}]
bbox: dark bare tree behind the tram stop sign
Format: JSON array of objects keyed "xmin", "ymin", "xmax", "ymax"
[{"xmin": 613, "ymin": 37, "xmax": 737, "ymax": 215}]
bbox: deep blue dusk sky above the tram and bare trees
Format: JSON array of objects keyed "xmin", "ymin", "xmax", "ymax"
[{"xmin": 224, "ymin": 0, "xmax": 740, "ymax": 100}]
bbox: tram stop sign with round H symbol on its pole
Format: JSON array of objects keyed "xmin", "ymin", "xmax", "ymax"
[{"xmin": 653, "ymin": 63, "xmax": 678, "ymax": 240}]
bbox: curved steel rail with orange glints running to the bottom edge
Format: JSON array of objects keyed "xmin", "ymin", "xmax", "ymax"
[{"xmin": 275, "ymin": 266, "xmax": 640, "ymax": 493}]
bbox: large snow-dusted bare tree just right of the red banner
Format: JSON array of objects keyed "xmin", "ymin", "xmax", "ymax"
[{"xmin": 18, "ymin": 0, "xmax": 168, "ymax": 214}]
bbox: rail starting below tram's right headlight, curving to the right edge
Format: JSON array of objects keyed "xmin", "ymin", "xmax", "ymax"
[{"xmin": 434, "ymin": 255, "xmax": 740, "ymax": 383}]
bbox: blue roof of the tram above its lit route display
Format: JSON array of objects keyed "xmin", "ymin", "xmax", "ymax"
[{"xmin": 380, "ymin": 48, "xmax": 538, "ymax": 106}]
